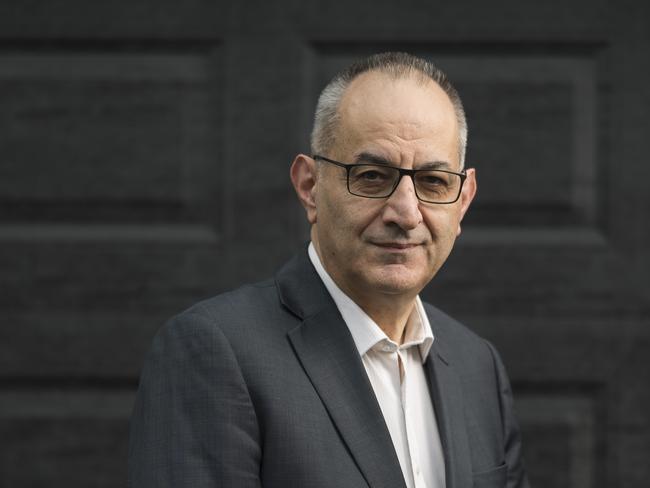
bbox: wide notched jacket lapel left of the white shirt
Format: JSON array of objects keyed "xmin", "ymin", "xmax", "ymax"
[{"xmin": 276, "ymin": 253, "xmax": 406, "ymax": 488}]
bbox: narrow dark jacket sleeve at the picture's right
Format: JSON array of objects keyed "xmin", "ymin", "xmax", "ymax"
[{"xmin": 486, "ymin": 341, "xmax": 530, "ymax": 488}]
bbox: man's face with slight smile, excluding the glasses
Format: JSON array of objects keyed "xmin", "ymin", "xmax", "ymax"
[{"xmin": 311, "ymin": 72, "xmax": 475, "ymax": 302}]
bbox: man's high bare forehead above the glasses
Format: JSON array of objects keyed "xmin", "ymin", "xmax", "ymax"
[{"xmin": 337, "ymin": 71, "xmax": 458, "ymax": 162}]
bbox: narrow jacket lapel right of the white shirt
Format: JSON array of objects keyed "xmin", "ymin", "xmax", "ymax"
[{"xmin": 425, "ymin": 336, "xmax": 472, "ymax": 488}]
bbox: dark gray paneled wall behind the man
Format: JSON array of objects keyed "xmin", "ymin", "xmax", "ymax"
[{"xmin": 0, "ymin": 0, "xmax": 650, "ymax": 488}]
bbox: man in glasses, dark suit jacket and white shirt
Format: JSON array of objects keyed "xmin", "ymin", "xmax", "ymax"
[{"xmin": 129, "ymin": 53, "xmax": 528, "ymax": 488}]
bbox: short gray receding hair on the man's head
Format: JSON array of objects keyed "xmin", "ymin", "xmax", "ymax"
[{"xmin": 311, "ymin": 52, "xmax": 467, "ymax": 169}]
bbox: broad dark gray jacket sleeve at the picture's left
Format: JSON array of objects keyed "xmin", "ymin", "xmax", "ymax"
[{"xmin": 128, "ymin": 309, "xmax": 261, "ymax": 488}]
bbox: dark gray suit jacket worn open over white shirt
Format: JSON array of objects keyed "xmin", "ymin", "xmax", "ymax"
[{"xmin": 129, "ymin": 252, "xmax": 528, "ymax": 488}]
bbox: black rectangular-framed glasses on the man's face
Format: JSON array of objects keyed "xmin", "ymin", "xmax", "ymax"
[{"xmin": 313, "ymin": 154, "xmax": 467, "ymax": 204}]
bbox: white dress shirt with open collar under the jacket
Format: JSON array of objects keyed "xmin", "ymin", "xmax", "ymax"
[{"xmin": 309, "ymin": 243, "xmax": 445, "ymax": 488}]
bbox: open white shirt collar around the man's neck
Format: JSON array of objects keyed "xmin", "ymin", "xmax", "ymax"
[{"xmin": 307, "ymin": 242, "xmax": 434, "ymax": 362}]
